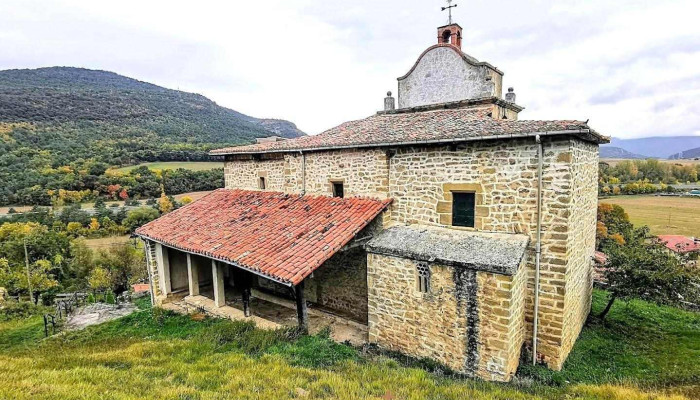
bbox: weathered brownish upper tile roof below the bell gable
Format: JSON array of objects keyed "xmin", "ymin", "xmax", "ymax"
[{"xmin": 211, "ymin": 107, "xmax": 608, "ymax": 155}]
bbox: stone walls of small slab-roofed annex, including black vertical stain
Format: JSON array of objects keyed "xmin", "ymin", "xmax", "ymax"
[{"xmin": 367, "ymin": 254, "xmax": 526, "ymax": 381}]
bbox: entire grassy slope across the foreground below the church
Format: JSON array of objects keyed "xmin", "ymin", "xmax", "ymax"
[{"xmin": 0, "ymin": 291, "xmax": 700, "ymax": 400}]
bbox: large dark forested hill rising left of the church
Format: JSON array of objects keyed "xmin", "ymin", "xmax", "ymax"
[{"xmin": 0, "ymin": 67, "xmax": 303, "ymax": 159}]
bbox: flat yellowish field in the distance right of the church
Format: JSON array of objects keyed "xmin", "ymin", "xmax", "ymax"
[{"xmin": 600, "ymin": 196, "xmax": 700, "ymax": 237}]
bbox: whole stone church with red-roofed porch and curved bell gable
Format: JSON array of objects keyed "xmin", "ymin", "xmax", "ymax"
[{"xmin": 137, "ymin": 24, "xmax": 608, "ymax": 381}]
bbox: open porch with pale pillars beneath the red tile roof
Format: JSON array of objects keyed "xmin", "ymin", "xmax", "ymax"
[{"xmin": 154, "ymin": 244, "xmax": 368, "ymax": 345}]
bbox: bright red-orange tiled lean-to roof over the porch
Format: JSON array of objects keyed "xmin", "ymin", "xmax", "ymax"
[{"xmin": 136, "ymin": 189, "xmax": 391, "ymax": 285}]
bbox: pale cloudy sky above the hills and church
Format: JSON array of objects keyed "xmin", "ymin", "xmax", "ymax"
[{"xmin": 0, "ymin": 0, "xmax": 700, "ymax": 138}]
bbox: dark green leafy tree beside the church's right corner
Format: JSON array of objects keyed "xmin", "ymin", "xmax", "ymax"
[{"xmin": 599, "ymin": 241, "xmax": 700, "ymax": 319}]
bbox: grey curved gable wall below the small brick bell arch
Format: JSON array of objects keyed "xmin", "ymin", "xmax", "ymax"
[{"xmin": 398, "ymin": 46, "xmax": 501, "ymax": 108}]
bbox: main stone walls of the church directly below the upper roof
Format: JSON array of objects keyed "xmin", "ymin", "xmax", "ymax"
[{"xmin": 226, "ymin": 137, "xmax": 598, "ymax": 371}]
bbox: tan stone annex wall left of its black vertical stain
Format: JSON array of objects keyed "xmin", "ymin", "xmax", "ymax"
[{"xmin": 367, "ymin": 254, "xmax": 475, "ymax": 371}]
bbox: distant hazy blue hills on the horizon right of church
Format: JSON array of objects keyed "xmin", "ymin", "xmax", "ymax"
[{"xmin": 601, "ymin": 136, "xmax": 700, "ymax": 158}]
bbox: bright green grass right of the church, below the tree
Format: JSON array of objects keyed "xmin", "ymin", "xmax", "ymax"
[{"xmin": 520, "ymin": 291, "xmax": 700, "ymax": 395}]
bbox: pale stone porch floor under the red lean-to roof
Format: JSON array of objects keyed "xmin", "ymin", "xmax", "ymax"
[{"xmin": 163, "ymin": 288, "xmax": 368, "ymax": 346}]
